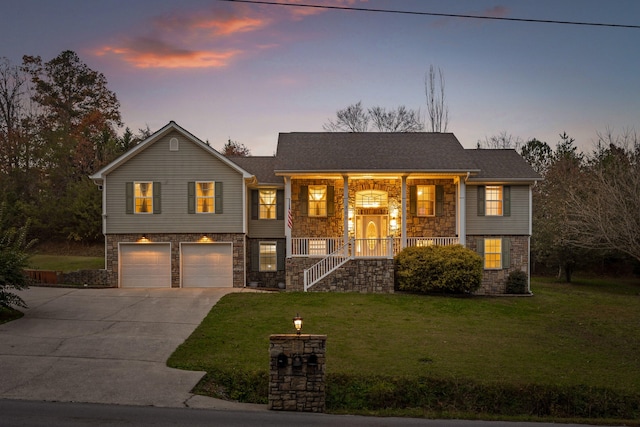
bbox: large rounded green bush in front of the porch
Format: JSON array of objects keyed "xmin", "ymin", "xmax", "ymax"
[{"xmin": 395, "ymin": 245, "xmax": 482, "ymax": 293}]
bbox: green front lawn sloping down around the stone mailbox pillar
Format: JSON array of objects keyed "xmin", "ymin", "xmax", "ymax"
[{"xmin": 168, "ymin": 280, "xmax": 640, "ymax": 419}]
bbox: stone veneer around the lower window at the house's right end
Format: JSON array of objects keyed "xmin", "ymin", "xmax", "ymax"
[{"xmin": 467, "ymin": 236, "xmax": 529, "ymax": 295}]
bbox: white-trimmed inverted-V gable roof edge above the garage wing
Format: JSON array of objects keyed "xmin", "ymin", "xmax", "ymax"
[{"xmin": 89, "ymin": 121, "xmax": 252, "ymax": 183}]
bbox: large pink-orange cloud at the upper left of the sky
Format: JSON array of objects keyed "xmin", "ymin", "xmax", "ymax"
[{"xmin": 96, "ymin": 0, "xmax": 367, "ymax": 68}]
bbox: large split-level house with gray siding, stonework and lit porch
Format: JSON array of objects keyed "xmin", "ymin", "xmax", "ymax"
[{"xmin": 91, "ymin": 122, "xmax": 540, "ymax": 294}]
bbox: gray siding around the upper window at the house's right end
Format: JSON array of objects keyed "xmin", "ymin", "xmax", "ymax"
[{"xmin": 465, "ymin": 184, "xmax": 530, "ymax": 235}]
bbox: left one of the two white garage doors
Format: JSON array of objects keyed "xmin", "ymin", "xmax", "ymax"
[{"xmin": 119, "ymin": 243, "xmax": 171, "ymax": 288}]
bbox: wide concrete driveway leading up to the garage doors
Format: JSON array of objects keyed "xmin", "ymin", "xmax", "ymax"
[{"xmin": 0, "ymin": 287, "xmax": 268, "ymax": 410}]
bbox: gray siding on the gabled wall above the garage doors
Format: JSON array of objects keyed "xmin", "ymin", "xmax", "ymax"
[{"xmin": 104, "ymin": 132, "xmax": 244, "ymax": 234}]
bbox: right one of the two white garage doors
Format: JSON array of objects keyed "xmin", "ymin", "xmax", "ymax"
[{"xmin": 180, "ymin": 243, "xmax": 233, "ymax": 288}]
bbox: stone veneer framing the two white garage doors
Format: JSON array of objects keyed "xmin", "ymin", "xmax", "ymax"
[{"xmin": 106, "ymin": 233, "xmax": 245, "ymax": 288}]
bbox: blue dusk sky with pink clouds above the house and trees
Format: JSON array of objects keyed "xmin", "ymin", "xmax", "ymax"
[{"xmin": 0, "ymin": 0, "xmax": 640, "ymax": 155}]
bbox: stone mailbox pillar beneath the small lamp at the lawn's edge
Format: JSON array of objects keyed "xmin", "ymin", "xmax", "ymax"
[{"xmin": 269, "ymin": 334, "xmax": 327, "ymax": 412}]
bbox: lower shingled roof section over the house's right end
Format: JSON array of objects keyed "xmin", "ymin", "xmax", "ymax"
[{"xmin": 466, "ymin": 149, "xmax": 542, "ymax": 181}]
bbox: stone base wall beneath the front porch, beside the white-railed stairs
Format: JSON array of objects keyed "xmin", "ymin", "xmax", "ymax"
[{"xmin": 286, "ymin": 258, "xmax": 394, "ymax": 293}]
